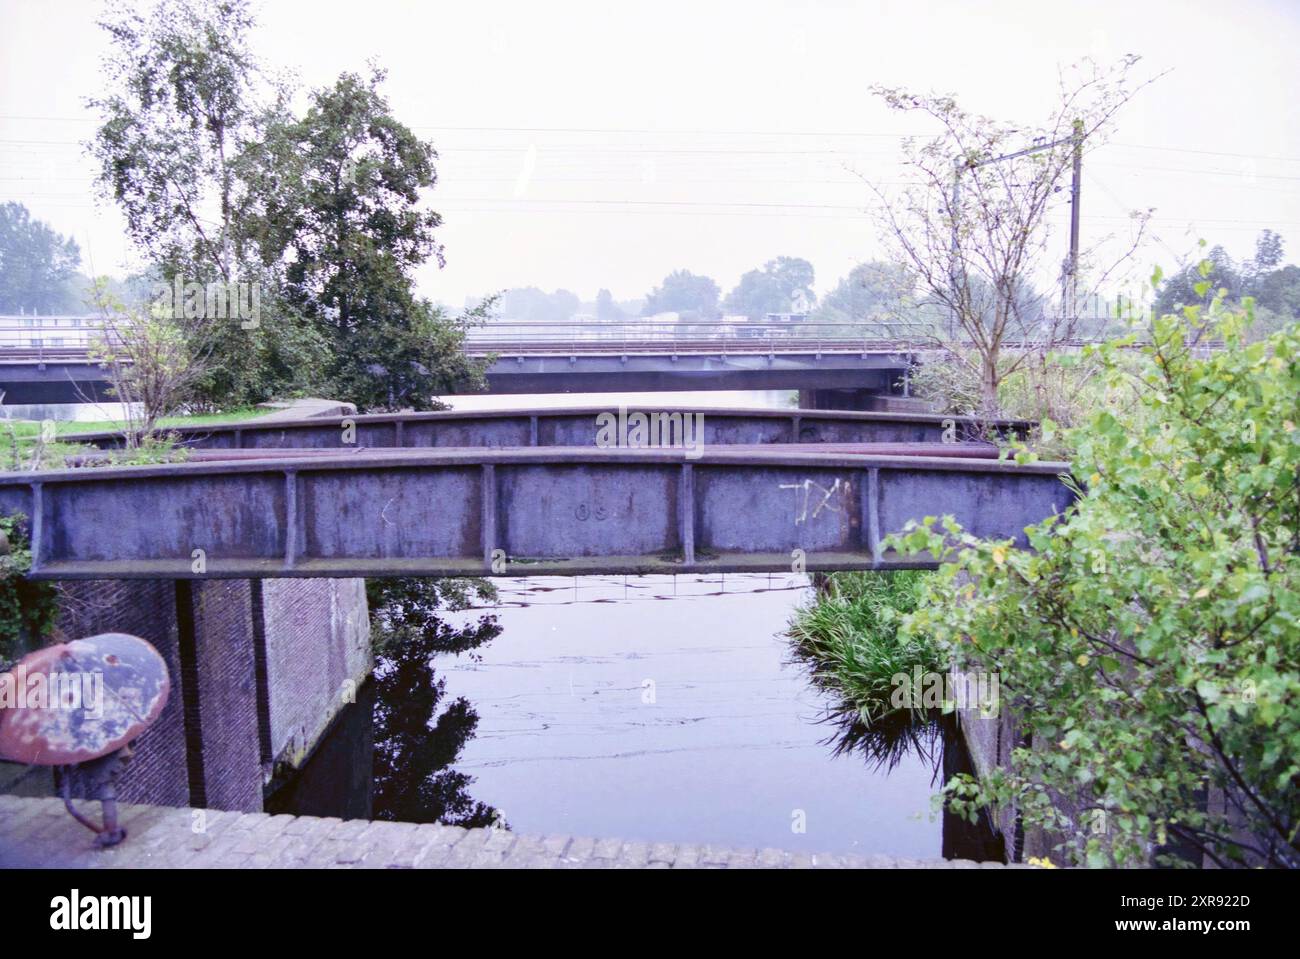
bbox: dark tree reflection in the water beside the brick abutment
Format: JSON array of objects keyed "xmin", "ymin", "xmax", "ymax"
[{"xmin": 367, "ymin": 580, "xmax": 506, "ymax": 826}]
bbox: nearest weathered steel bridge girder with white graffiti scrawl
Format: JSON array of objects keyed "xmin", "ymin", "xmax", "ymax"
[{"xmin": 0, "ymin": 447, "xmax": 1073, "ymax": 580}]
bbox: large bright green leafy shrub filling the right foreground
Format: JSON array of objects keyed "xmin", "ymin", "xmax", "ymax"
[{"xmin": 889, "ymin": 280, "xmax": 1300, "ymax": 868}]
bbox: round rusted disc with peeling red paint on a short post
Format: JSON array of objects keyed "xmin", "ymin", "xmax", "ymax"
[{"xmin": 0, "ymin": 633, "xmax": 172, "ymax": 765}]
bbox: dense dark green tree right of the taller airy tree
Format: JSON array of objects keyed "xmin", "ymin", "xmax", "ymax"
[{"xmin": 241, "ymin": 69, "xmax": 494, "ymax": 411}]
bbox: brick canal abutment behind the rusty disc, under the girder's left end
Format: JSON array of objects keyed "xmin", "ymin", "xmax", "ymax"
[{"xmin": 8, "ymin": 580, "xmax": 372, "ymax": 812}]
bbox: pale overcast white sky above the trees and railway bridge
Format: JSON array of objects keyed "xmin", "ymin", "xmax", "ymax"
[{"xmin": 0, "ymin": 0, "xmax": 1300, "ymax": 304}]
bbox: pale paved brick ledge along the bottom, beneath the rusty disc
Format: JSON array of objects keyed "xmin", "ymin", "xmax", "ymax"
[{"xmin": 0, "ymin": 795, "xmax": 1006, "ymax": 869}]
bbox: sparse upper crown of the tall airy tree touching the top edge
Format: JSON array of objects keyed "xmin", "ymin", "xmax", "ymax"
[{"xmin": 87, "ymin": 0, "xmax": 271, "ymax": 282}]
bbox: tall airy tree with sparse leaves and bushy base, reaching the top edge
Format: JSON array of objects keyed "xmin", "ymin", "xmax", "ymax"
[{"xmin": 87, "ymin": 0, "xmax": 312, "ymax": 407}]
